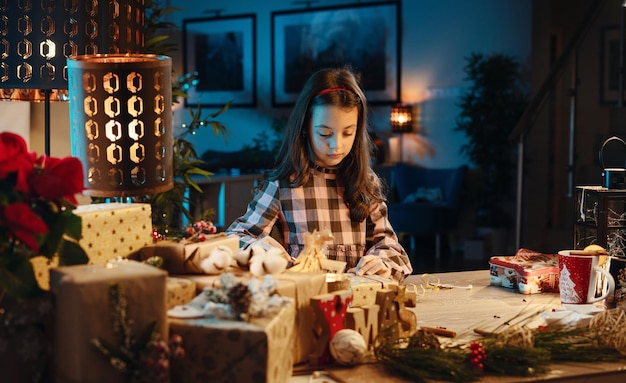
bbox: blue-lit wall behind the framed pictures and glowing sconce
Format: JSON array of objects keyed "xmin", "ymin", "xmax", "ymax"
[{"xmin": 170, "ymin": 0, "xmax": 532, "ymax": 167}]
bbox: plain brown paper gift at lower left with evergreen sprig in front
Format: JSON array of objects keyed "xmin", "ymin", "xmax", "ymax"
[{"xmin": 50, "ymin": 261, "xmax": 168, "ymax": 383}]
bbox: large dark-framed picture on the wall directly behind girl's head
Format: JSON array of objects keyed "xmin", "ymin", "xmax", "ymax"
[{"xmin": 272, "ymin": 1, "xmax": 401, "ymax": 107}]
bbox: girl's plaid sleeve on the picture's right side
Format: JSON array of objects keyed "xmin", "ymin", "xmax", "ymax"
[{"xmin": 366, "ymin": 202, "xmax": 413, "ymax": 281}]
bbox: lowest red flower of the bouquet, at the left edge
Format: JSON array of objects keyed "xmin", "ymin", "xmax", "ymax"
[{"xmin": 0, "ymin": 202, "xmax": 48, "ymax": 251}]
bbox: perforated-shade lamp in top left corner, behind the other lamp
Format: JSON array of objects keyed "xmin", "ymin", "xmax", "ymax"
[{"xmin": 0, "ymin": 0, "xmax": 145, "ymax": 155}]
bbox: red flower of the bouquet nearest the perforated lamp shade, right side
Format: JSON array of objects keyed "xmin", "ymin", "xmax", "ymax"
[{"xmin": 29, "ymin": 156, "xmax": 84, "ymax": 204}]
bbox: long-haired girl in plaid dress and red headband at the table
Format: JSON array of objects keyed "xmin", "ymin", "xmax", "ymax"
[{"xmin": 226, "ymin": 69, "xmax": 413, "ymax": 280}]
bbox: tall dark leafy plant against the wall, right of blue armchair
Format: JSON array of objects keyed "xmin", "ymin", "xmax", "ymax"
[{"xmin": 455, "ymin": 53, "xmax": 528, "ymax": 249}]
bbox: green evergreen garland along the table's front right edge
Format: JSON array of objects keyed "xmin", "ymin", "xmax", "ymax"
[{"xmin": 374, "ymin": 309, "xmax": 626, "ymax": 382}]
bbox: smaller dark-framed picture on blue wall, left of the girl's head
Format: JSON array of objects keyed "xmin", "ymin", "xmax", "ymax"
[{"xmin": 183, "ymin": 14, "xmax": 257, "ymax": 107}]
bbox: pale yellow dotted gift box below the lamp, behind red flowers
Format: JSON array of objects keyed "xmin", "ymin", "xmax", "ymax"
[{"xmin": 31, "ymin": 203, "xmax": 152, "ymax": 290}]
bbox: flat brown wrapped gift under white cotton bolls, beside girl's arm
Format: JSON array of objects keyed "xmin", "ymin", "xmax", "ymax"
[{"xmin": 130, "ymin": 233, "xmax": 239, "ymax": 274}]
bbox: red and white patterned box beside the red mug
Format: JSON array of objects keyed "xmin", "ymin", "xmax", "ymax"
[{"xmin": 489, "ymin": 249, "xmax": 559, "ymax": 294}]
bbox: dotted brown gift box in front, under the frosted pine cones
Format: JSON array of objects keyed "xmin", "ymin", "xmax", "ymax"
[{"xmin": 169, "ymin": 302, "xmax": 295, "ymax": 383}]
